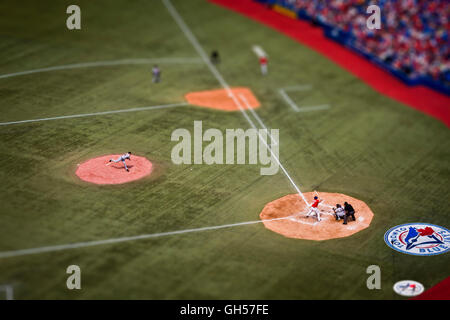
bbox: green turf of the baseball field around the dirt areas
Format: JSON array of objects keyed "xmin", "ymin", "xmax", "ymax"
[{"xmin": 0, "ymin": 0, "xmax": 450, "ymax": 299}]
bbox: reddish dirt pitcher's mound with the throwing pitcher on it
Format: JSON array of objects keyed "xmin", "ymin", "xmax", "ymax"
[{"xmin": 75, "ymin": 154, "xmax": 152, "ymax": 184}]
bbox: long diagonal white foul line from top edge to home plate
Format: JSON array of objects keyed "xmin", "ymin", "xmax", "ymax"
[{"xmin": 162, "ymin": 0, "xmax": 308, "ymax": 204}]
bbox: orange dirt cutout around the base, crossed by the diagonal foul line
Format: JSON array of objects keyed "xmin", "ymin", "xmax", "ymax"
[{"xmin": 185, "ymin": 87, "xmax": 260, "ymax": 111}]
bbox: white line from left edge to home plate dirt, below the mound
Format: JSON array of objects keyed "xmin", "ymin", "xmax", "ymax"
[{"xmin": 0, "ymin": 217, "xmax": 289, "ymax": 259}]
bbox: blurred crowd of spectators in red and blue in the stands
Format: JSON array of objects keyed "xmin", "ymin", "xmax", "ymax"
[{"xmin": 282, "ymin": 0, "xmax": 450, "ymax": 86}]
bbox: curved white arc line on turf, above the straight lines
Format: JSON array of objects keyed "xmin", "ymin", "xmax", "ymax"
[{"xmin": 0, "ymin": 58, "xmax": 203, "ymax": 79}]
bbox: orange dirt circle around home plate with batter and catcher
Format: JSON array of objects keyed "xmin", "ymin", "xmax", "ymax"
[{"xmin": 259, "ymin": 192, "xmax": 373, "ymax": 240}]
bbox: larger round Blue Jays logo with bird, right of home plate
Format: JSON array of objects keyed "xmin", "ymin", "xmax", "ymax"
[{"xmin": 384, "ymin": 223, "xmax": 450, "ymax": 256}]
